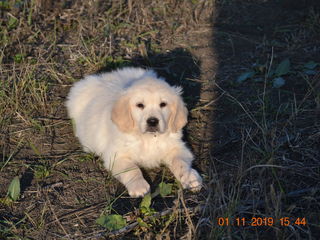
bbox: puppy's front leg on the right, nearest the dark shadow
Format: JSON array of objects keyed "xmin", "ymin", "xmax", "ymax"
[{"xmin": 166, "ymin": 148, "xmax": 202, "ymax": 192}]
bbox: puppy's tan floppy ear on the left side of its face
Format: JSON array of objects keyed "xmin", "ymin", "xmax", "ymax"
[{"xmin": 111, "ymin": 94, "xmax": 134, "ymax": 132}]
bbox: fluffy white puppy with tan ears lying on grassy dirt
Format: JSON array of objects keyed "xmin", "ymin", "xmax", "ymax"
[{"xmin": 66, "ymin": 68, "xmax": 202, "ymax": 197}]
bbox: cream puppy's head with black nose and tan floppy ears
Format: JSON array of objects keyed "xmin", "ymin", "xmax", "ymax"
[{"xmin": 111, "ymin": 78, "xmax": 188, "ymax": 134}]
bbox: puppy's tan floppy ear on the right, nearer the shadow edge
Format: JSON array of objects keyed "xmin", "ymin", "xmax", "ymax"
[{"xmin": 169, "ymin": 92, "xmax": 188, "ymax": 132}]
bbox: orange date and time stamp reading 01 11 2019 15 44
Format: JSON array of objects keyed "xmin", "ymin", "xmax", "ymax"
[{"xmin": 217, "ymin": 217, "xmax": 307, "ymax": 227}]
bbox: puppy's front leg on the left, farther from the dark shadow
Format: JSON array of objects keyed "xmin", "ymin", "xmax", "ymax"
[{"xmin": 110, "ymin": 159, "xmax": 150, "ymax": 197}]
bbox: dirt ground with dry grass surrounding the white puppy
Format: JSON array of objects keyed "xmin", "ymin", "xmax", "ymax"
[{"xmin": 0, "ymin": 0, "xmax": 320, "ymax": 239}]
